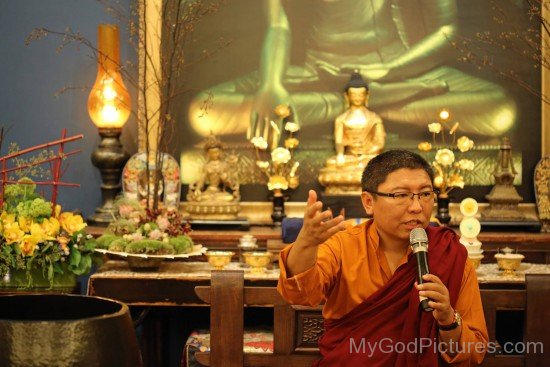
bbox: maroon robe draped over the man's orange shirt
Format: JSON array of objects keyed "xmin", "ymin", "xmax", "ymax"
[{"xmin": 314, "ymin": 227, "xmax": 468, "ymax": 367}]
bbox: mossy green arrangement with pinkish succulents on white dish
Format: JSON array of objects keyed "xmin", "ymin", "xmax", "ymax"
[{"xmin": 97, "ymin": 198, "xmax": 193, "ymax": 255}]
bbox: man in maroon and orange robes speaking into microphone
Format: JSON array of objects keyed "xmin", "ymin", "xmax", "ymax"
[{"xmin": 278, "ymin": 150, "xmax": 488, "ymax": 366}]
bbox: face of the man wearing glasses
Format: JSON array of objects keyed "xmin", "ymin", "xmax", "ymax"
[{"xmin": 361, "ymin": 168, "xmax": 434, "ymax": 245}]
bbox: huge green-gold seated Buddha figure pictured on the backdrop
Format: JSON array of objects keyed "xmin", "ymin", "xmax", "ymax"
[{"xmin": 188, "ymin": 0, "xmax": 517, "ymax": 144}]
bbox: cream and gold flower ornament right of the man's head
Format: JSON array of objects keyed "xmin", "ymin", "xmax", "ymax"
[{"xmin": 418, "ymin": 110, "xmax": 474, "ymax": 197}]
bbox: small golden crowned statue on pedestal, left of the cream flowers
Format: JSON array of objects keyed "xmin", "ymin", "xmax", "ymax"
[{"xmin": 185, "ymin": 135, "xmax": 240, "ymax": 220}]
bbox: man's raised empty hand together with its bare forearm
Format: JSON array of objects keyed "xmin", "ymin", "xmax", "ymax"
[{"xmin": 287, "ymin": 190, "xmax": 346, "ymax": 277}]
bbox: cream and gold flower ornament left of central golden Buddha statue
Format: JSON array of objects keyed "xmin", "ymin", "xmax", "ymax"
[{"xmin": 250, "ymin": 105, "xmax": 300, "ymax": 194}]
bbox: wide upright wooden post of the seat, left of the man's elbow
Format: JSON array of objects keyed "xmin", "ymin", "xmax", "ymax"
[{"xmin": 210, "ymin": 270, "xmax": 244, "ymax": 367}]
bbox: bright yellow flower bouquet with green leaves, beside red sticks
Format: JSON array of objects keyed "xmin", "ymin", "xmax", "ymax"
[{"xmin": 0, "ymin": 178, "xmax": 95, "ymax": 288}]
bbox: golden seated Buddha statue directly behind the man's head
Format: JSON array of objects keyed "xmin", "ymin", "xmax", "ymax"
[{"xmin": 319, "ymin": 72, "xmax": 386, "ymax": 194}]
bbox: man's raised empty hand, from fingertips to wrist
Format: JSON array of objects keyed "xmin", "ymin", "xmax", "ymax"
[{"xmin": 296, "ymin": 190, "xmax": 346, "ymax": 246}]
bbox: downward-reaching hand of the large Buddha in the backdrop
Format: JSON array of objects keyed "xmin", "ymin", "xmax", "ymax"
[{"xmin": 251, "ymin": 85, "xmax": 300, "ymax": 148}]
